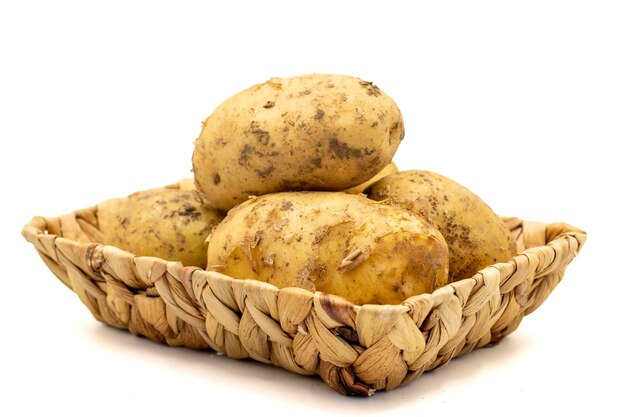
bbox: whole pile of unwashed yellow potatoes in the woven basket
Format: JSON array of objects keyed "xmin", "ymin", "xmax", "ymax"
[{"xmin": 98, "ymin": 74, "xmax": 515, "ymax": 305}]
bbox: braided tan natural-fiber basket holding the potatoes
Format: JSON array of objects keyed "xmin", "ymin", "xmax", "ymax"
[{"xmin": 22, "ymin": 184, "xmax": 586, "ymax": 396}]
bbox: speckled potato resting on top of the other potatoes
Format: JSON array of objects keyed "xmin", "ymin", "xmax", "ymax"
[{"xmin": 192, "ymin": 74, "xmax": 404, "ymax": 210}]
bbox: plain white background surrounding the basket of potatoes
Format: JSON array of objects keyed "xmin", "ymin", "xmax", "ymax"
[{"xmin": 0, "ymin": 0, "xmax": 626, "ymax": 416}]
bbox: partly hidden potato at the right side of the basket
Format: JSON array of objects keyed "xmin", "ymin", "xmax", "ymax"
[{"xmin": 365, "ymin": 170, "xmax": 516, "ymax": 280}]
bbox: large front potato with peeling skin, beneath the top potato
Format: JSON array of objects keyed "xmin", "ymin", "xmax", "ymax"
[{"xmin": 208, "ymin": 191, "xmax": 448, "ymax": 304}]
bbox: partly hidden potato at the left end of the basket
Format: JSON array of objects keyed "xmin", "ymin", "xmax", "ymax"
[{"xmin": 98, "ymin": 188, "xmax": 224, "ymax": 268}]
